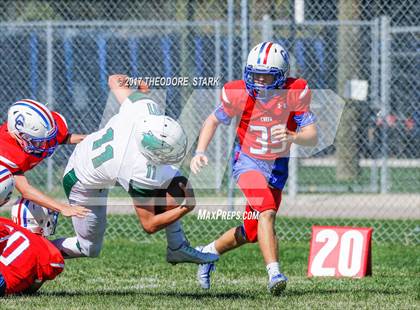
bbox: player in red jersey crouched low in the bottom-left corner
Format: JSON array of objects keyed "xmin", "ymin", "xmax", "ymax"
[{"xmin": 0, "ymin": 211, "xmax": 64, "ymax": 297}]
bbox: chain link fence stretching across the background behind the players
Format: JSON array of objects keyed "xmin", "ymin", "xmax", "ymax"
[{"xmin": 0, "ymin": 0, "xmax": 420, "ymax": 244}]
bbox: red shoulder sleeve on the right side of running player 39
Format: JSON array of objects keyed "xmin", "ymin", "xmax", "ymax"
[{"xmin": 287, "ymin": 79, "xmax": 312, "ymax": 115}]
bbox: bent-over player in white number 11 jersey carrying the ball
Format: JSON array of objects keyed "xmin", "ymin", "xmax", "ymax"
[{"xmin": 54, "ymin": 75, "xmax": 218, "ymax": 264}]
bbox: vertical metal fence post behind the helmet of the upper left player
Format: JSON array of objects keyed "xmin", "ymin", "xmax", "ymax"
[{"xmin": 46, "ymin": 21, "xmax": 54, "ymax": 191}]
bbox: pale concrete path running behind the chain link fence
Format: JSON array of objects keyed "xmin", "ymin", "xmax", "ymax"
[{"xmin": 2, "ymin": 193, "xmax": 420, "ymax": 220}]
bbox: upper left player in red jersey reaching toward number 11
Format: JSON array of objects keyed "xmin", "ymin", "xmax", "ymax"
[{"xmin": 0, "ymin": 99, "xmax": 88, "ymax": 217}]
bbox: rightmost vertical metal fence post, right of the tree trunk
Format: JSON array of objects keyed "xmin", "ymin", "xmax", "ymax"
[{"xmin": 381, "ymin": 16, "xmax": 390, "ymax": 194}]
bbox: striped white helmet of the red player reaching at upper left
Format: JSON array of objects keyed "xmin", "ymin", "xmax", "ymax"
[{"xmin": 7, "ymin": 99, "xmax": 58, "ymax": 156}]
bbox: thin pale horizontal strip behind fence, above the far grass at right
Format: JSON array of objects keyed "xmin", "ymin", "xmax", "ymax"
[{"xmin": 299, "ymin": 158, "xmax": 420, "ymax": 168}]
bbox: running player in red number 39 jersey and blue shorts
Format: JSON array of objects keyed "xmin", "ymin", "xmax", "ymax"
[{"xmin": 190, "ymin": 42, "xmax": 317, "ymax": 295}]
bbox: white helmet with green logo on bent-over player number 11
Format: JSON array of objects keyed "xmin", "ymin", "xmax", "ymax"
[{"xmin": 136, "ymin": 115, "xmax": 188, "ymax": 165}]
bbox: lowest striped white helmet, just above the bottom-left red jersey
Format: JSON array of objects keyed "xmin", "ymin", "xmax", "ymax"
[{"xmin": 12, "ymin": 198, "xmax": 58, "ymax": 237}]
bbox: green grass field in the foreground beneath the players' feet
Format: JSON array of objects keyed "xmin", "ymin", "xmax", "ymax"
[{"xmin": 0, "ymin": 240, "xmax": 420, "ymax": 309}]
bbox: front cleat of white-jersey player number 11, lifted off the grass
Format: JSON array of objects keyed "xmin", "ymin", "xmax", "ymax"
[{"xmin": 166, "ymin": 241, "xmax": 219, "ymax": 265}]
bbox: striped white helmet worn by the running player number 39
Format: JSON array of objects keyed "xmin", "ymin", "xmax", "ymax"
[{"xmin": 244, "ymin": 42, "xmax": 290, "ymax": 104}]
